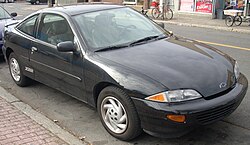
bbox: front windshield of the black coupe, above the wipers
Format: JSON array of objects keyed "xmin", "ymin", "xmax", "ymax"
[{"xmin": 74, "ymin": 8, "xmax": 168, "ymax": 51}]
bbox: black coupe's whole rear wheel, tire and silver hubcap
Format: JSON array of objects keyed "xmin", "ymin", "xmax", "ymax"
[{"xmin": 9, "ymin": 52, "xmax": 30, "ymax": 87}]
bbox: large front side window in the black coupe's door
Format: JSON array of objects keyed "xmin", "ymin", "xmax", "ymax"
[{"xmin": 38, "ymin": 14, "xmax": 74, "ymax": 45}]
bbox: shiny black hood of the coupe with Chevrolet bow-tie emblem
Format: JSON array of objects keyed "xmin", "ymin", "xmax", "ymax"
[{"xmin": 98, "ymin": 37, "xmax": 235, "ymax": 97}]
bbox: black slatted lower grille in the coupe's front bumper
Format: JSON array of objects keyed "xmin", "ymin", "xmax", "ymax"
[{"xmin": 196, "ymin": 104, "xmax": 235, "ymax": 125}]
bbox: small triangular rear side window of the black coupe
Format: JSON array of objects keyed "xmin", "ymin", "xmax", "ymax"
[{"xmin": 17, "ymin": 15, "xmax": 38, "ymax": 36}]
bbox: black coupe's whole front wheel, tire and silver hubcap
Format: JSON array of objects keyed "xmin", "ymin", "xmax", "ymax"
[{"xmin": 97, "ymin": 86, "xmax": 142, "ymax": 141}]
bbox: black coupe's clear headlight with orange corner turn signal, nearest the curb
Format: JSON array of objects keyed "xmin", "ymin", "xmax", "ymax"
[{"xmin": 145, "ymin": 89, "xmax": 202, "ymax": 102}]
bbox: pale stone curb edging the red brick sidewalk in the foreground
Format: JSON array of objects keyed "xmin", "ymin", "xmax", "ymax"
[{"xmin": 0, "ymin": 86, "xmax": 87, "ymax": 145}]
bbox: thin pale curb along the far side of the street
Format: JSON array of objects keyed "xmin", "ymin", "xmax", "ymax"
[{"xmin": 154, "ymin": 20, "xmax": 250, "ymax": 34}]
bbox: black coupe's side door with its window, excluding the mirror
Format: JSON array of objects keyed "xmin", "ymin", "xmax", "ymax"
[{"xmin": 30, "ymin": 13, "xmax": 85, "ymax": 101}]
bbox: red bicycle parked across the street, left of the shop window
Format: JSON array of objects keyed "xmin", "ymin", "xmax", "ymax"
[{"xmin": 151, "ymin": 3, "xmax": 173, "ymax": 20}]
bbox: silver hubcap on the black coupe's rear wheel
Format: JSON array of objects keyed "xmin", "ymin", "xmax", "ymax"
[{"xmin": 10, "ymin": 58, "xmax": 21, "ymax": 82}]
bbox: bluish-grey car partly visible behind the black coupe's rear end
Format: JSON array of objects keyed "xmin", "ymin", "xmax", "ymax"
[{"xmin": 0, "ymin": 6, "xmax": 17, "ymax": 56}]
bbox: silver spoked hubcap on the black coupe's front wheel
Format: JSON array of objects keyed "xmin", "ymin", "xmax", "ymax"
[{"xmin": 101, "ymin": 96, "xmax": 128, "ymax": 133}]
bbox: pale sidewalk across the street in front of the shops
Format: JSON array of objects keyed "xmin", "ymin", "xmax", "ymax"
[{"xmin": 131, "ymin": 5, "xmax": 250, "ymax": 34}]
